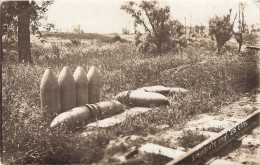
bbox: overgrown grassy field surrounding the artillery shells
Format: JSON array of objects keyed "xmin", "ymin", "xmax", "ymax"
[{"xmin": 2, "ymin": 33, "xmax": 258, "ymax": 164}]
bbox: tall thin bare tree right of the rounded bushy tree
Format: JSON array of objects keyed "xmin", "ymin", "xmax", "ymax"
[{"xmin": 234, "ymin": 2, "xmax": 246, "ymax": 53}]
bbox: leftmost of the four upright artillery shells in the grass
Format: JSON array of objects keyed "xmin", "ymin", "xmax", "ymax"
[{"xmin": 40, "ymin": 68, "xmax": 61, "ymax": 115}]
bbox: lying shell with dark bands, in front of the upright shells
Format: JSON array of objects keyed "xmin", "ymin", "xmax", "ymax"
[{"xmin": 50, "ymin": 100, "xmax": 124, "ymax": 128}]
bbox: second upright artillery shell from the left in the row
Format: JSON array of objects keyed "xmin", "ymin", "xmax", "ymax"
[{"xmin": 58, "ymin": 66, "xmax": 76, "ymax": 112}]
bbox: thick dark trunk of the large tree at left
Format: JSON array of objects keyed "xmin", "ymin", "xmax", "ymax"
[{"xmin": 18, "ymin": 1, "xmax": 32, "ymax": 63}]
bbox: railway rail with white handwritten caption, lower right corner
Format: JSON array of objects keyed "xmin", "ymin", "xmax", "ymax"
[{"xmin": 167, "ymin": 110, "xmax": 260, "ymax": 165}]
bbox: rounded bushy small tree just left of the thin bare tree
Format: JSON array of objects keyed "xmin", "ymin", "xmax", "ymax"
[{"xmin": 209, "ymin": 9, "xmax": 236, "ymax": 53}]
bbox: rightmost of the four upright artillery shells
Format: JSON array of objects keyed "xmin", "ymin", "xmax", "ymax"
[{"xmin": 87, "ymin": 66, "xmax": 101, "ymax": 104}]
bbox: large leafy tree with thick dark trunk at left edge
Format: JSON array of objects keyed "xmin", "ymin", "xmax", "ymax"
[{"xmin": 1, "ymin": 0, "xmax": 53, "ymax": 63}]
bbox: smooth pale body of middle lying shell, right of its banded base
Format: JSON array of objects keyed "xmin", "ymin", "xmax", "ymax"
[{"xmin": 129, "ymin": 90, "xmax": 169, "ymax": 107}]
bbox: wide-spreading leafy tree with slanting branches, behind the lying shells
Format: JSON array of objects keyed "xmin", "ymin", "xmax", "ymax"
[{"xmin": 121, "ymin": 1, "xmax": 183, "ymax": 53}]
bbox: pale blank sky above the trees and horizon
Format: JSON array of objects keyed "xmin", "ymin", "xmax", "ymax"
[{"xmin": 44, "ymin": 0, "xmax": 260, "ymax": 33}]
